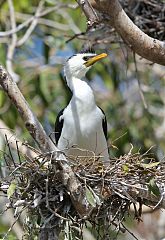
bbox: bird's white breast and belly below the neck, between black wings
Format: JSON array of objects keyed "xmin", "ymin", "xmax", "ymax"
[{"xmin": 58, "ymin": 104, "xmax": 109, "ymax": 160}]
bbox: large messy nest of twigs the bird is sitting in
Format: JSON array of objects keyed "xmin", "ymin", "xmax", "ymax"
[{"xmin": 0, "ymin": 141, "xmax": 165, "ymax": 239}]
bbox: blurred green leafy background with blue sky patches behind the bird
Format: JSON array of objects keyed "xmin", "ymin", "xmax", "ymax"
[{"xmin": 0, "ymin": 0, "xmax": 165, "ymax": 240}]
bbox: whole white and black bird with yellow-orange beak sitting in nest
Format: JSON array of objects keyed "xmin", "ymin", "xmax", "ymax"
[{"xmin": 55, "ymin": 53, "xmax": 109, "ymax": 164}]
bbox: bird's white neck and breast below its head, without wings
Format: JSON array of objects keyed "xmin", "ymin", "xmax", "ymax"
[{"xmin": 58, "ymin": 77, "xmax": 109, "ymax": 164}]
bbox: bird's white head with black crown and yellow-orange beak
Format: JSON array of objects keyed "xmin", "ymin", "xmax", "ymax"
[{"xmin": 64, "ymin": 53, "xmax": 107, "ymax": 78}]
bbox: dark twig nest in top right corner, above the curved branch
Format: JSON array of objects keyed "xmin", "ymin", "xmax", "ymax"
[{"xmin": 120, "ymin": 0, "xmax": 165, "ymax": 40}]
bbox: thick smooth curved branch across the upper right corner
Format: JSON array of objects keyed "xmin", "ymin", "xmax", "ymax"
[{"xmin": 89, "ymin": 0, "xmax": 165, "ymax": 65}]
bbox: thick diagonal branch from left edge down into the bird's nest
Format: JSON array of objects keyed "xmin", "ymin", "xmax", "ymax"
[{"xmin": 0, "ymin": 65, "xmax": 92, "ymax": 216}]
